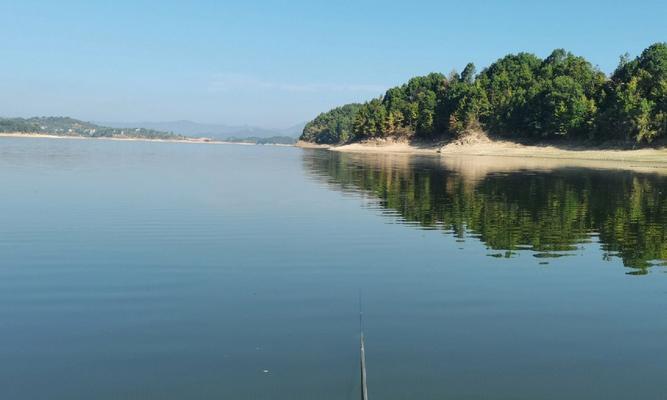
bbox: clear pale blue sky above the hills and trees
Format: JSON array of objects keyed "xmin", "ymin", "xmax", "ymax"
[{"xmin": 0, "ymin": 0, "xmax": 667, "ymax": 127}]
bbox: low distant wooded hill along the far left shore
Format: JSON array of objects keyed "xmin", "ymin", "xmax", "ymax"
[{"xmin": 0, "ymin": 117, "xmax": 184, "ymax": 139}]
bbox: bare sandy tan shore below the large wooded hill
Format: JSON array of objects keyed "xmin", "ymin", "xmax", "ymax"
[{"xmin": 296, "ymin": 133, "xmax": 667, "ymax": 168}]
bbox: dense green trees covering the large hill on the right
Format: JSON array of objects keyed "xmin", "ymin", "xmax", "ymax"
[{"xmin": 301, "ymin": 43, "xmax": 667, "ymax": 143}]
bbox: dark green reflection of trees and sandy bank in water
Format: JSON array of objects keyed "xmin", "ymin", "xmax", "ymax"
[{"xmin": 303, "ymin": 151, "xmax": 667, "ymax": 275}]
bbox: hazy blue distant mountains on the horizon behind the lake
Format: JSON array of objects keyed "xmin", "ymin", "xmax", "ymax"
[{"xmin": 100, "ymin": 120, "xmax": 306, "ymax": 140}]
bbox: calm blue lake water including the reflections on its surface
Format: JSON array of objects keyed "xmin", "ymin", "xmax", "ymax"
[{"xmin": 0, "ymin": 138, "xmax": 667, "ymax": 400}]
